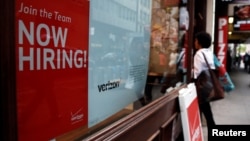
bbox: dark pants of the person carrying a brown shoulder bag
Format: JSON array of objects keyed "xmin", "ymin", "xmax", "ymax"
[{"xmin": 199, "ymin": 102, "xmax": 215, "ymax": 128}]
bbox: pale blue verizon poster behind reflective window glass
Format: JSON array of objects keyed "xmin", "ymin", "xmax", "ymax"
[{"xmin": 89, "ymin": 0, "xmax": 151, "ymax": 126}]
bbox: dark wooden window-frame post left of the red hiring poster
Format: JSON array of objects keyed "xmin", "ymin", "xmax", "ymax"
[{"xmin": 0, "ymin": 0, "xmax": 17, "ymax": 141}]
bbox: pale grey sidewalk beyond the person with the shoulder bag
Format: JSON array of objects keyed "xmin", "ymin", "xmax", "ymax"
[{"xmin": 203, "ymin": 67, "xmax": 250, "ymax": 141}]
